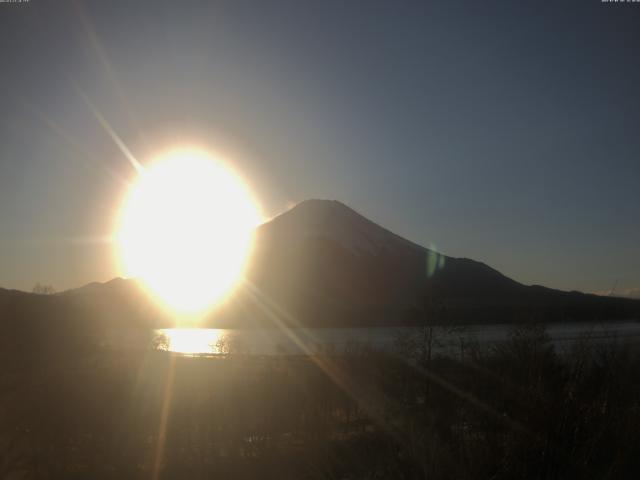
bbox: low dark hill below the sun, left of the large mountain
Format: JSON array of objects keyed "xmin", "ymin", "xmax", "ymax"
[{"xmin": 0, "ymin": 278, "xmax": 163, "ymax": 364}]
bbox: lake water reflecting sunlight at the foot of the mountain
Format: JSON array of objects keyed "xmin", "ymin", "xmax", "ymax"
[{"xmin": 154, "ymin": 320, "xmax": 640, "ymax": 355}]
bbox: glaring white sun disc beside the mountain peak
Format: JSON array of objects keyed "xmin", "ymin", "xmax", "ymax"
[{"xmin": 117, "ymin": 150, "xmax": 260, "ymax": 314}]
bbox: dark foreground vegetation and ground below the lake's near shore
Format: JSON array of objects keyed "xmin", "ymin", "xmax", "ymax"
[{"xmin": 0, "ymin": 326, "xmax": 640, "ymax": 479}]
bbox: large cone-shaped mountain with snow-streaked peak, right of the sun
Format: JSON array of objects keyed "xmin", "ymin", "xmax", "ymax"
[{"xmin": 231, "ymin": 200, "xmax": 640, "ymax": 325}]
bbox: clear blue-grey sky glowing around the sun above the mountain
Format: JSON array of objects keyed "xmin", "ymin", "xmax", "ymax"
[{"xmin": 0, "ymin": 0, "xmax": 640, "ymax": 293}]
